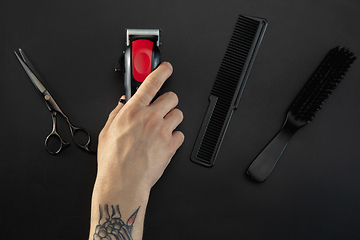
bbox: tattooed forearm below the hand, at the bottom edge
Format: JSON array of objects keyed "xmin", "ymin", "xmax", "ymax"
[{"xmin": 89, "ymin": 180, "xmax": 149, "ymax": 240}]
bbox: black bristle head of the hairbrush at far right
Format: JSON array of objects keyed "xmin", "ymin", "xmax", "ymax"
[{"xmin": 290, "ymin": 47, "xmax": 356, "ymax": 122}]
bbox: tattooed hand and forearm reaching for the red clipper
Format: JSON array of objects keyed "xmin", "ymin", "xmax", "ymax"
[{"xmin": 89, "ymin": 62, "xmax": 184, "ymax": 240}]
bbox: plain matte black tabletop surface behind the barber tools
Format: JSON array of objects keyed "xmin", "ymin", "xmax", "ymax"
[{"xmin": 0, "ymin": 0, "xmax": 360, "ymax": 240}]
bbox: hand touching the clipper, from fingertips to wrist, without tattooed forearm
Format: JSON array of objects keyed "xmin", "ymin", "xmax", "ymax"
[{"xmin": 97, "ymin": 63, "xmax": 184, "ymax": 191}]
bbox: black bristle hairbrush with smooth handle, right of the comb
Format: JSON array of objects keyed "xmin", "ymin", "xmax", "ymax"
[{"xmin": 247, "ymin": 47, "xmax": 356, "ymax": 182}]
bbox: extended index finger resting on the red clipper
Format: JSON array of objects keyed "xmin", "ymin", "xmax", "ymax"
[{"xmin": 133, "ymin": 62, "xmax": 173, "ymax": 106}]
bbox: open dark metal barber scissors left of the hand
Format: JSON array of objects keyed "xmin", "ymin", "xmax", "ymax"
[{"xmin": 14, "ymin": 49, "xmax": 95, "ymax": 154}]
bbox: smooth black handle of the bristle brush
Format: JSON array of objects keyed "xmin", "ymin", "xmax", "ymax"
[{"xmin": 247, "ymin": 119, "xmax": 300, "ymax": 182}]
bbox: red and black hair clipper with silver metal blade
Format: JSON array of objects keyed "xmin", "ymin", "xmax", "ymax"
[{"xmin": 115, "ymin": 29, "xmax": 161, "ymax": 100}]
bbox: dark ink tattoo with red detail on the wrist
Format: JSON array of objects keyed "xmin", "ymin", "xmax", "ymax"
[{"xmin": 93, "ymin": 204, "xmax": 140, "ymax": 240}]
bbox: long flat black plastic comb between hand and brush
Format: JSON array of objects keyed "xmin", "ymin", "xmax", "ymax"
[{"xmin": 191, "ymin": 15, "xmax": 267, "ymax": 167}]
